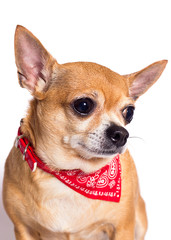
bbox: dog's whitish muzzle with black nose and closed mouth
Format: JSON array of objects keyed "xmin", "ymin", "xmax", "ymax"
[{"xmin": 69, "ymin": 124, "xmax": 129, "ymax": 159}]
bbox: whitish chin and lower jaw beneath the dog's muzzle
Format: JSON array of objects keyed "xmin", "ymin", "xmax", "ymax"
[{"xmin": 77, "ymin": 144, "xmax": 126, "ymax": 160}]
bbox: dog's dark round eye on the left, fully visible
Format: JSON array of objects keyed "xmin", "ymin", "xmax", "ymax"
[{"xmin": 72, "ymin": 98, "xmax": 95, "ymax": 115}]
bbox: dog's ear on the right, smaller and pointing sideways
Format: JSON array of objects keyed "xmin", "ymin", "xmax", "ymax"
[{"xmin": 126, "ymin": 60, "xmax": 168, "ymax": 100}]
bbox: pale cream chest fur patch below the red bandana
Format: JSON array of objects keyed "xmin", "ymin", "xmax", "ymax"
[{"xmin": 34, "ymin": 178, "xmax": 110, "ymax": 233}]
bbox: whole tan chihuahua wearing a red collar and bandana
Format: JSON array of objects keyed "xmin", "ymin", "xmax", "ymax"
[{"xmin": 3, "ymin": 26, "xmax": 167, "ymax": 240}]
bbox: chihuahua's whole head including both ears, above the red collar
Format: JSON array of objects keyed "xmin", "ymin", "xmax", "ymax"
[{"xmin": 15, "ymin": 26, "xmax": 167, "ymax": 172}]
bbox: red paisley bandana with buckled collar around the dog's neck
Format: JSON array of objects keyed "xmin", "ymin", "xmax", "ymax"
[{"xmin": 16, "ymin": 128, "xmax": 121, "ymax": 202}]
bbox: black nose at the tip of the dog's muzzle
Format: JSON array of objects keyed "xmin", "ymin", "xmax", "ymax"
[{"xmin": 106, "ymin": 124, "xmax": 129, "ymax": 147}]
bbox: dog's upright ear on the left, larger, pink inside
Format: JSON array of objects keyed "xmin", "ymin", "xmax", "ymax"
[{"xmin": 15, "ymin": 26, "xmax": 57, "ymax": 99}]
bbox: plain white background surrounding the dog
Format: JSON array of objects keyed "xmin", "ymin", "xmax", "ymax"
[{"xmin": 0, "ymin": 0, "xmax": 171, "ymax": 240}]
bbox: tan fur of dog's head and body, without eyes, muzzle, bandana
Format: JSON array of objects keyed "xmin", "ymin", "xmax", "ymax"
[{"xmin": 3, "ymin": 27, "xmax": 166, "ymax": 240}]
